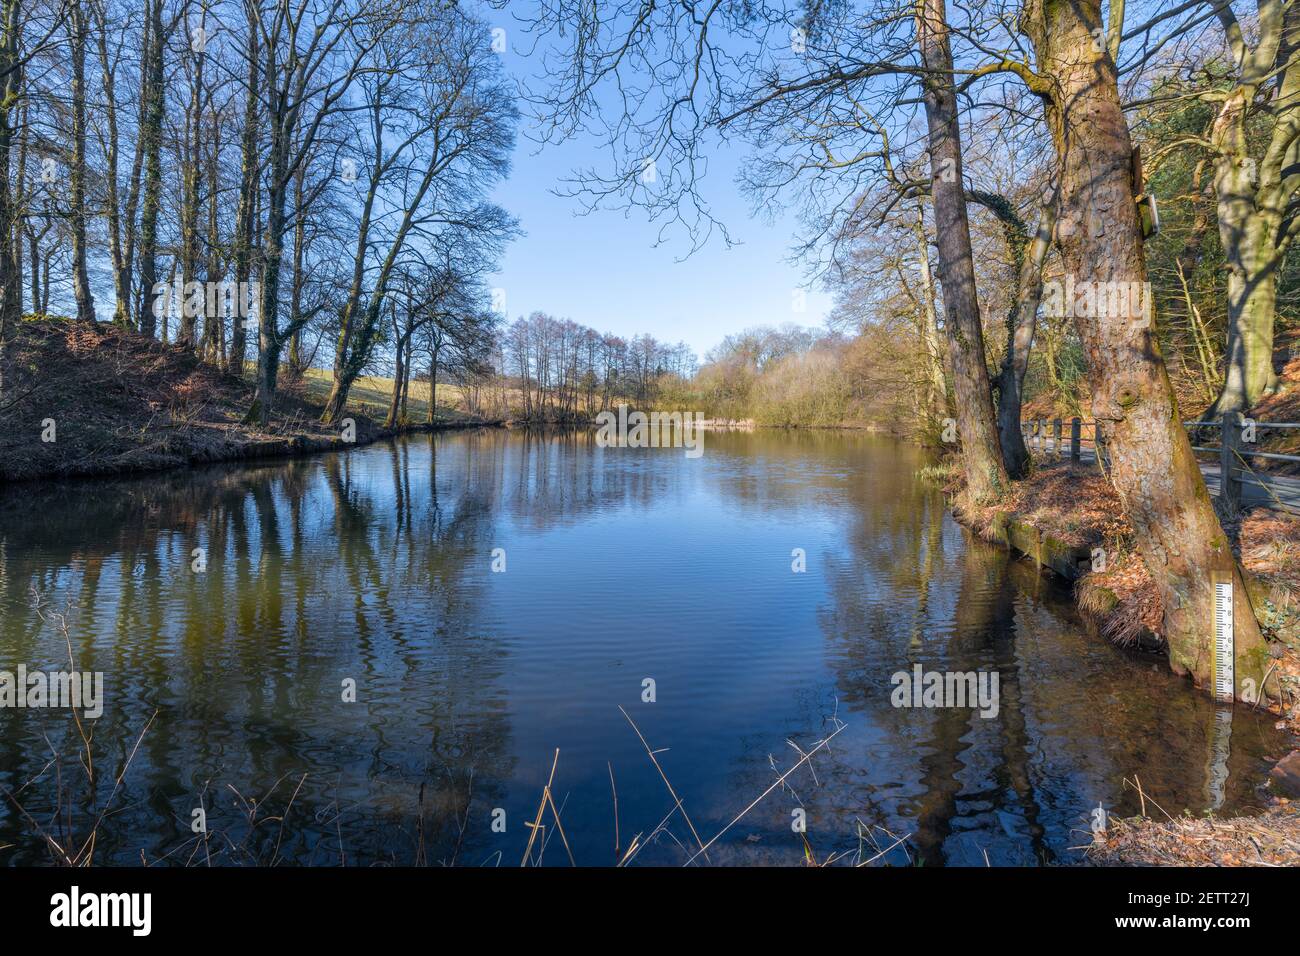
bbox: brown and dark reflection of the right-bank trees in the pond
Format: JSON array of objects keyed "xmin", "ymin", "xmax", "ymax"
[{"xmin": 823, "ymin": 468, "xmax": 1284, "ymax": 865}]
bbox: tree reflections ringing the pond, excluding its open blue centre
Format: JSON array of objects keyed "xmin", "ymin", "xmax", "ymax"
[{"xmin": 0, "ymin": 429, "xmax": 1271, "ymax": 864}]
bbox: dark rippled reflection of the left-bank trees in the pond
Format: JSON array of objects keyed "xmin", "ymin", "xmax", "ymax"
[{"xmin": 0, "ymin": 436, "xmax": 566, "ymax": 862}]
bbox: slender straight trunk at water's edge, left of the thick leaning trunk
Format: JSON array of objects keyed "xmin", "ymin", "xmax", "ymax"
[{"xmin": 917, "ymin": 0, "xmax": 1008, "ymax": 503}]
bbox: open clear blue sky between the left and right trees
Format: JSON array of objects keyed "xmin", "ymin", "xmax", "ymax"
[{"xmin": 493, "ymin": 18, "xmax": 831, "ymax": 358}]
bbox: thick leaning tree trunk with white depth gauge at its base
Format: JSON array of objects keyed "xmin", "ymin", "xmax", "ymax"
[{"xmin": 1022, "ymin": 0, "xmax": 1268, "ymax": 695}]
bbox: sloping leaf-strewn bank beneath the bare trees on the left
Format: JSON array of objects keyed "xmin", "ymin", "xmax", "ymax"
[{"xmin": 0, "ymin": 320, "xmax": 489, "ymax": 481}]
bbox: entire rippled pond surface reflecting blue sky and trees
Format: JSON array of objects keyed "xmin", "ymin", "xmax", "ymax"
[{"xmin": 0, "ymin": 431, "xmax": 1278, "ymax": 865}]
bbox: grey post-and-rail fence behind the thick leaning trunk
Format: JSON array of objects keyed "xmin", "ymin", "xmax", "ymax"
[{"xmin": 1021, "ymin": 412, "xmax": 1300, "ymax": 511}]
